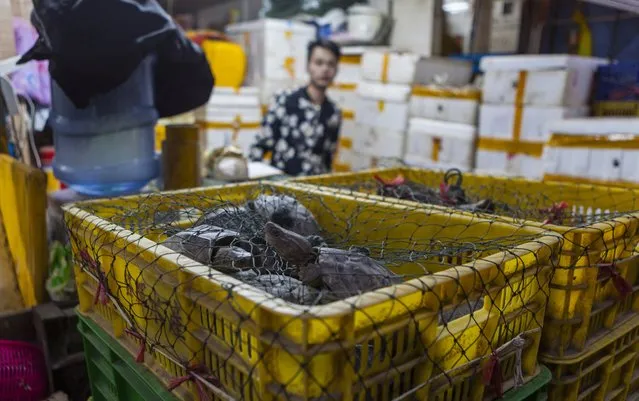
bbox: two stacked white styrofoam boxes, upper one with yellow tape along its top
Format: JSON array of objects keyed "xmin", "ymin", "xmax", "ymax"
[{"xmin": 405, "ymin": 85, "xmax": 480, "ymax": 171}]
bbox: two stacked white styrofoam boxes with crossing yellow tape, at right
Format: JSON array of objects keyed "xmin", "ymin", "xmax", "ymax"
[{"xmin": 476, "ymin": 55, "xmax": 606, "ymax": 178}]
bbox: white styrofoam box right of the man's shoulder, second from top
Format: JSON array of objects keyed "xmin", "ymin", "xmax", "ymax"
[{"xmin": 355, "ymin": 82, "xmax": 410, "ymax": 131}]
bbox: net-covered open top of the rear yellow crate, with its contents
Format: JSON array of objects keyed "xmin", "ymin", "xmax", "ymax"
[{"xmin": 298, "ymin": 168, "xmax": 639, "ymax": 228}]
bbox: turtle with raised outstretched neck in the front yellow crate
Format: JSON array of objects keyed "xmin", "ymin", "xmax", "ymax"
[{"xmin": 264, "ymin": 222, "xmax": 402, "ymax": 297}]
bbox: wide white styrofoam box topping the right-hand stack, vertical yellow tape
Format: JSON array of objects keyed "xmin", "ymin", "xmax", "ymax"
[{"xmin": 480, "ymin": 55, "xmax": 607, "ymax": 107}]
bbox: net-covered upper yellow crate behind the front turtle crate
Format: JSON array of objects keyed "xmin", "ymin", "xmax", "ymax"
[{"xmin": 299, "ymin": 168, "xmax": 639, "ymax": 357}]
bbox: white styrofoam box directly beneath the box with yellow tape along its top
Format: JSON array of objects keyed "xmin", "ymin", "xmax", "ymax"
[{"xmin": 406, "ymin": 118, "xmax": 477, "ymax": 169}]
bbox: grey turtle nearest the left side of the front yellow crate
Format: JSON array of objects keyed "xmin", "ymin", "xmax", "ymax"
[{"xmin": 162, "ymin": 224, "xmax": 256, "ymax": 273}]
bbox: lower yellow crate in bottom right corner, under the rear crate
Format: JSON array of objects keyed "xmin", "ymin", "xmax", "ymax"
[{"xmin": 540, "ymin": 317, "xmax": 639, "ymax": 401}]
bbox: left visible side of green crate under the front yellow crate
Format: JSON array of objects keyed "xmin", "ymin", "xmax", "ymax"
[{"xmin": 78, "ymin": 314, "xmax": 178, "ymax": 401}]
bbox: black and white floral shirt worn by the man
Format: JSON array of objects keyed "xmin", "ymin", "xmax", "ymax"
[{"xmin": 250, "ymin": 87, "xmax": 342, "ymax": 176}]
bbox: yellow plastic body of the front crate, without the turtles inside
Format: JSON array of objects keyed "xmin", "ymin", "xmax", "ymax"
[{"xmin": 65, "ymin": 184, "xmax": 561, "ymax": 401}]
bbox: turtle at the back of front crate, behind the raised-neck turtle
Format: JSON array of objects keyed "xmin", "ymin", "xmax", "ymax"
[{"xmin": 246, "ymin": 194, "xmax": 320, "ymax": 237}]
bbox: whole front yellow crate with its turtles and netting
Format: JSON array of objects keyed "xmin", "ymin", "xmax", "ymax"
[{"xmin": 66, "ymin": 184, "xmax": 561, "ymax": 400}]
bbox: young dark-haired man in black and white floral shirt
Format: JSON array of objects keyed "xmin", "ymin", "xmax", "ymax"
[{"xmin": 250, "ymin": 40, "xmax": 342, "ymax": 176}]
